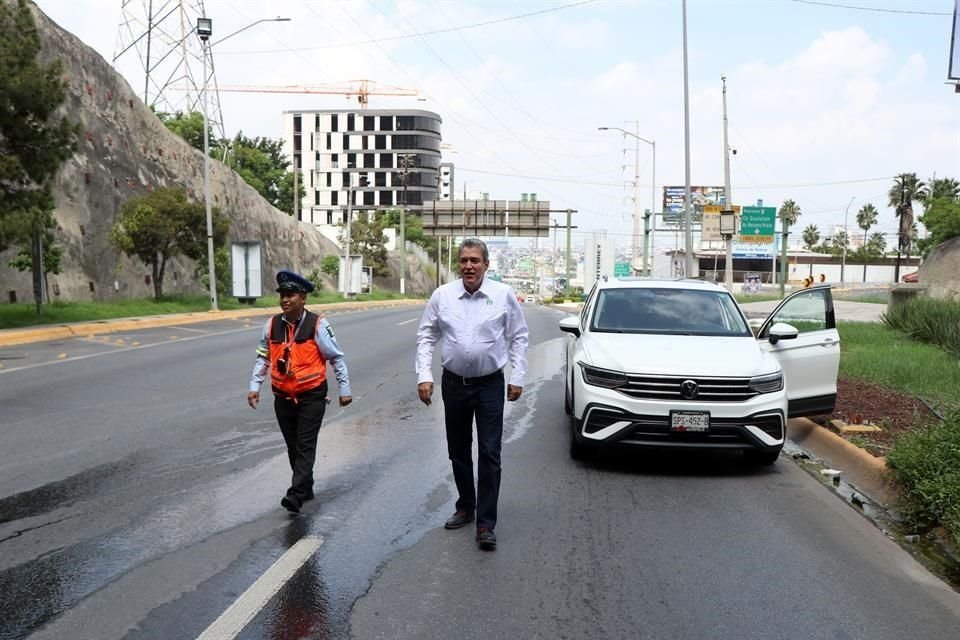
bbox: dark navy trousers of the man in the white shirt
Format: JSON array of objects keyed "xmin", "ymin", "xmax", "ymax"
[{"xmin": 441, "ymin": 372, "xmax": 505, "ymax": 529}]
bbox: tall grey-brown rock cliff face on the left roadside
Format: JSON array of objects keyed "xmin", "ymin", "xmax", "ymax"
[{"xmin": 0, "ymin": 0, "xmax": 344, "ymax": 302}]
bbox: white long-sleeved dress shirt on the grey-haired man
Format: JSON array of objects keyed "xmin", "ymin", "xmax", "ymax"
[{"xmin": 416, "ymin": 278, "xmax": 529, "ymax": 387}]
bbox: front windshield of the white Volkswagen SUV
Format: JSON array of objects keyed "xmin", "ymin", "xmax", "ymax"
[{"xmin": 591, "ymin": 287, "xmax": 752, "ymax": 336}]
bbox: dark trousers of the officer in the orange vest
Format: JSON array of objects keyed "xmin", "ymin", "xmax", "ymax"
[{"xmin": 273, "ymin": 382, "xmax": 327, "ymax": 502}]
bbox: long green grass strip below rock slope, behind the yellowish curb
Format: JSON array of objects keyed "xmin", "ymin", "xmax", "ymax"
[{"xmin": 0, "ymin": 291, "xmax": 415, "ymax": 329}]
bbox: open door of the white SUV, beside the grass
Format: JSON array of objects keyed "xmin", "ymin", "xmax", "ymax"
[{"xmin": 757, "ymin": 286, "xmax": 840, "ymax": 418}]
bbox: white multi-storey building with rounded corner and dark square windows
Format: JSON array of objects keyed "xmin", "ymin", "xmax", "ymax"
[{"xmin": 283, "ymin": 109, "xmax": 440, "ymax": 241}]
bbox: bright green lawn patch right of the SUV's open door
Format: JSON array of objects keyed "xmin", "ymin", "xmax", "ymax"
[{"xmin": 838, "ymin": 322, "xmax": 960, "ymax": 407}]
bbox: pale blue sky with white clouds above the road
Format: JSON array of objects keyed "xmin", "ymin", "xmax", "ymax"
[{"xmin": 38, "ymin": 0, "xmax": 960, "ymax": 264}]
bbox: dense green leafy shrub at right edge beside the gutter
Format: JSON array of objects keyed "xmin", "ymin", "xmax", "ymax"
[{"xmin": 887, "ymin": 411, "xmax": 960, "ymax": 544}]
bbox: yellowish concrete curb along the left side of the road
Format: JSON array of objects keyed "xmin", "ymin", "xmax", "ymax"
[{"xmin": 0, "ymin": 300, "xmax": 424, "ymax": 347}]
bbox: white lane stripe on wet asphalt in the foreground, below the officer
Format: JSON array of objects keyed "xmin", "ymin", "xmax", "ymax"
[{"xmin": 197, "ymin": 537, "xmax": 323, "ymax": 640}]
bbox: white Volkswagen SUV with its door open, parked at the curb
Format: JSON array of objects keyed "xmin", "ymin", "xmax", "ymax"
[{"xmin": 560, "ymin": 278, "xmax": 840, "ymax": 464}]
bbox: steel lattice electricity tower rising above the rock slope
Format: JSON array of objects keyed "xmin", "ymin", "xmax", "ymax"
[{"xmin": 112, "ymin": 0, "xmax": 226, "ymax": 139}]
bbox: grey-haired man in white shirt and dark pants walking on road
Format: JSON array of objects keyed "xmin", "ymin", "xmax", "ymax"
[{"xmin": 416, "ymin": 238, "xmax": 528, "ymax": 551}]
